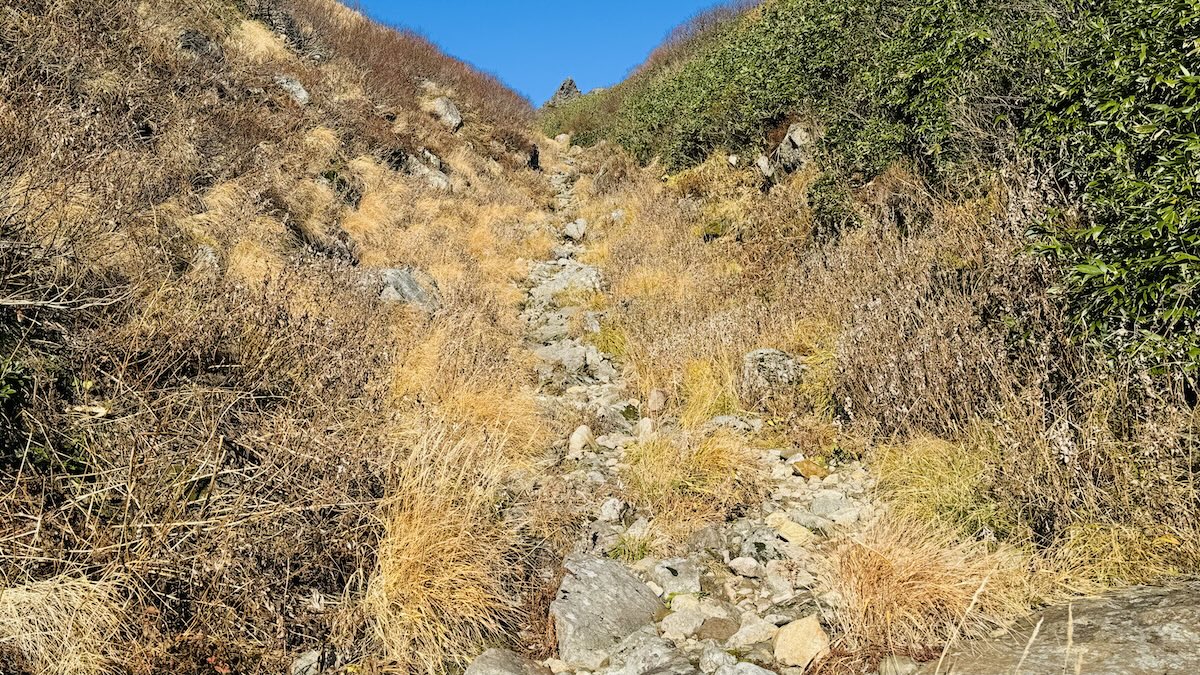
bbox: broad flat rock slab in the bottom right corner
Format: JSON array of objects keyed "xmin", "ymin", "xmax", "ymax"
[{"xmin": 919, "ymin": 583, "xmax": 1200, "ymax": 675}]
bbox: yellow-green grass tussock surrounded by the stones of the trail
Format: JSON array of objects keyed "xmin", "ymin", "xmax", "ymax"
[{"xmin": 623, "ymin": 431, "xmax": 767, "ymax": 540}]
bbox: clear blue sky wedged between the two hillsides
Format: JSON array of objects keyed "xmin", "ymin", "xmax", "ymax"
[{"xmin": 350, "ymin": 0, "xmax": 718, "ymax": 106}]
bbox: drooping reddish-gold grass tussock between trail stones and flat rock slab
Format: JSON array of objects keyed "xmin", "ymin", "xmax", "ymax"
[{"xmin": 821, "ymin": 518, "xmax": 1030, "ymax": 653}]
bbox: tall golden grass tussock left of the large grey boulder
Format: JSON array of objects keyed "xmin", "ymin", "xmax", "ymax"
[{"xmin": 364, "ymin": 431, "xmax": 522, "ymax": 673}]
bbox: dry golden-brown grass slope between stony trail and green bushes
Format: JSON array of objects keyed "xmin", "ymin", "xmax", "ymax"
[{"xmin": 566, "ymin": 132, "xmax": 1200, "ymax": 638}]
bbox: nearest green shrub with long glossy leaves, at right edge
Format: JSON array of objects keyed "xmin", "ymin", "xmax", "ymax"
[{"xmin": 1030, "ymin": 0, "xmax": 1200, "ymax": 370}]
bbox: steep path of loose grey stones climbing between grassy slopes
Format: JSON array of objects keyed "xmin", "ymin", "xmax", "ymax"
[{"xmin": 499, "ymin": 144, "xmax": 881, "ymax": 675}]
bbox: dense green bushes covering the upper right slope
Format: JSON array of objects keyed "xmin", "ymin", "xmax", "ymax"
[{"xmin": 544, "ymin": 0, "xmax": 1200, "ymax": 368}]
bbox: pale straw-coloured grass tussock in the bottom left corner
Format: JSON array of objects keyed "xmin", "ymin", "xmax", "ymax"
[{"xmin": 0, "ymin": 575, "xmax": 128, "ymax": 675}]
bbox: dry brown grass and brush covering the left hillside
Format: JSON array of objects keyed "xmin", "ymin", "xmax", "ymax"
[{"xmin": 0, "ymin": 0, "xmax": 552, "ymax": 673}]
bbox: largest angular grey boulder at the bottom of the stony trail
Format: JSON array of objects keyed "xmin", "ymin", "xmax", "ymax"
[{"xmin": 550, "ymin": 556, "xmax": 662, "ymax": 670}]
